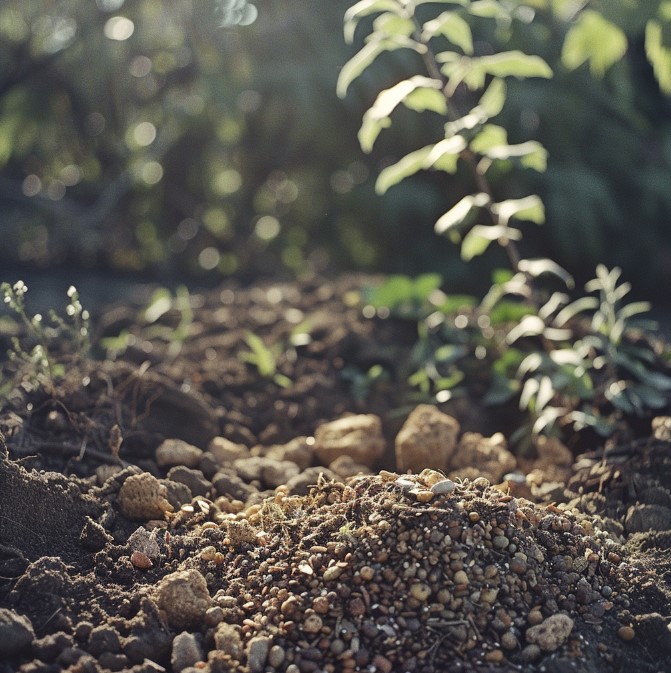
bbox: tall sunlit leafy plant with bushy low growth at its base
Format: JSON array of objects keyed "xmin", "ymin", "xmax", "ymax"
[{"xmin": 338, "ymin": 0, "xmax": 671, "ymax": 452}]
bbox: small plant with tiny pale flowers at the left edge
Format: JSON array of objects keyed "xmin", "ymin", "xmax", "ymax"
[{"xmin": 0, "ymin": 281, "xmax": 91, "ymax": 393}]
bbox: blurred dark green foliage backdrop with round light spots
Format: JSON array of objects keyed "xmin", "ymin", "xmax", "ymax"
[{"xmin": 0, "ymin": 0, "xmax": 671, "ymax": 305}]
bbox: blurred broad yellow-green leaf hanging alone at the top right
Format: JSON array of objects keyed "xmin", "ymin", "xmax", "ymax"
[{"xmin": 561, "ymin": 9, "xmax": 627, "ymax": 77}]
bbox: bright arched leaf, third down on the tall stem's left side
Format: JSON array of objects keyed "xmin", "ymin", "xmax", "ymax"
[{"xmin": 358, "ymin": 75, "xmax": 447, "ymax": 152}]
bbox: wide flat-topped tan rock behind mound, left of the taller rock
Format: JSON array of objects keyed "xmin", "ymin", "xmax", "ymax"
[{"xmin": 313, "ymin": 414, "xmax": 385, "ymax": 467}]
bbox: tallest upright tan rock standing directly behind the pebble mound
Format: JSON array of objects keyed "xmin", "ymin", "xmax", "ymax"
[{"xmin": 396, "ymin": 404, "xmax": 459, "ymax": 472}]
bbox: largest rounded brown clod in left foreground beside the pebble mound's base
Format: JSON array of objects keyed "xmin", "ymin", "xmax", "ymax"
[{"xmin": 157, "ymin": 568, "xmax": 211, "ymax": 629}]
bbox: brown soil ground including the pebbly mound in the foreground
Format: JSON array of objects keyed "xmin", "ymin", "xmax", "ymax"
[{"xmin": 0, "ymin": 277, "xmax": 671, "ymax": 673}]
